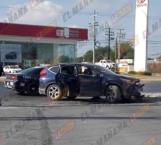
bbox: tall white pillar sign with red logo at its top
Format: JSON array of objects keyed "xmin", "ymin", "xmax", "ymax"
[{"xmin": 134, "ymin": 0, "xmax": 149, "ymax": 71}]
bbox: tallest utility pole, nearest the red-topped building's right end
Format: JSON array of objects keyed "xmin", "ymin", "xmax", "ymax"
[{"xmin": 90, "ymin": 10, "xmax": 98, "ymax": 64}]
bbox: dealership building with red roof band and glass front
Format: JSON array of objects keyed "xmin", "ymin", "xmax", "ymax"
[{"xmin": 0, "ymin": 23, "xmax": 88, "ymax": 67}]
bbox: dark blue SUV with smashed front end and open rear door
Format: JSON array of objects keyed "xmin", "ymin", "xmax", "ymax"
[{"xmin": 39, "ymin": 64, "xmax": 143, "ymax": 103}]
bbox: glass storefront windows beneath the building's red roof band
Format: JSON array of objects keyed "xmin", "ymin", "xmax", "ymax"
[{"xmin": 0, "ymin": 42, "xmax": 76, "ymax": 68}]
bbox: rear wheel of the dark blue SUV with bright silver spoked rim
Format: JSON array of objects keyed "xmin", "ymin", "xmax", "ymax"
[{"xmin": 47, "ymin": 84, "xmax": 63, "ymax": 101}]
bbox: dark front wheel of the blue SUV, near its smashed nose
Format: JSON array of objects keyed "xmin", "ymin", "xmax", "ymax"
[{"xmin": 105, "ymin": 85, "xmax": 122, "ymax": 103}]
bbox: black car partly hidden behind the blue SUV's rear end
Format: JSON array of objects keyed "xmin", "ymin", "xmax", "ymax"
[{"xmin": 14, "ymin": 67, "xmax": 44, "ymax": 95}]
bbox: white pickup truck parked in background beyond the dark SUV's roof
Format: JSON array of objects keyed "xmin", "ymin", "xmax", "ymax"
[{"xmin": 96, "ymin": 60, "xmax": 117, "ymax": 69}]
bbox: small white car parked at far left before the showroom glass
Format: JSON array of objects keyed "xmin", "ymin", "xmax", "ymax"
[{"xmin": 3, "ymin": 65, "xmax": 22, "ymax": 74}]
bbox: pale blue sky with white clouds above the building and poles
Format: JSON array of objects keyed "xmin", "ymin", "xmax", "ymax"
[{"xmin": 0, "ymin": 0, "xmax": 161, "ymax": 57}]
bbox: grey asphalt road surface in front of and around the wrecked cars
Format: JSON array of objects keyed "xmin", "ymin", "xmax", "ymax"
[{"xmin": 0, "ymin": 82, "xmax": 161, "ymax": 145}]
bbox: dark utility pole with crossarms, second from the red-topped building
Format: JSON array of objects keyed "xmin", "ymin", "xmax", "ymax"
[{"xmin": 105, "ymin": 28, "xmax": 115, "ymax": 60}]
